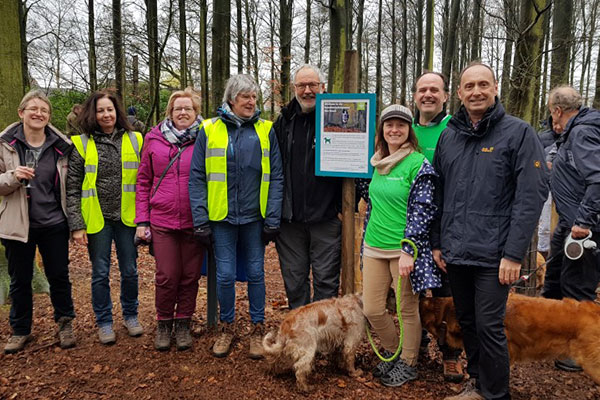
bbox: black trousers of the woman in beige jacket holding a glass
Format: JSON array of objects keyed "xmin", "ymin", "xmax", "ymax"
[{"xmin": 2, "ymin": 222, "xmax": 75, "ymax": 336}]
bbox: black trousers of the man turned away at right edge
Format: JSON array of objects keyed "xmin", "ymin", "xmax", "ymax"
[{"xmin": 542, "ymin": 224, "xmax": 600, "ymax": 301}]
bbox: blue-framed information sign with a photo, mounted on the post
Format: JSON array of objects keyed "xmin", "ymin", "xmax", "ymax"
[{"xmin": 316, "ymin": 94, "xmax": 375, "ymax": 177}]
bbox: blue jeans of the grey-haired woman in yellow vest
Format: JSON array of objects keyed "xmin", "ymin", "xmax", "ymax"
[{"xmin": 211, "ymin": 221, "xmax": 265, "ymax": 324}]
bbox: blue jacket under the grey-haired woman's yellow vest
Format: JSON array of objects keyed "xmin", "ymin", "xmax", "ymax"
[{"xmin": 189, "ymin": 108, "xmax": 283, "ymax": 227}]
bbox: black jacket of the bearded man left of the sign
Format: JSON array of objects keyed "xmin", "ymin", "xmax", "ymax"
[{"xmin": 273, "ymin": 98, "xmax": 342, "ymax": 223}]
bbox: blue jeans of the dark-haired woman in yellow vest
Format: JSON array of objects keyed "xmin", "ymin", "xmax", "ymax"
[{"xmin": 88, "ymin": 220, "xmax": 138, "ymax": 326}]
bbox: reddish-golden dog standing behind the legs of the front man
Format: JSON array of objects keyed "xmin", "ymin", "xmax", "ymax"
[{"xmin": 419, "ymin": 294, "xmax": 600, "ymax": 385}]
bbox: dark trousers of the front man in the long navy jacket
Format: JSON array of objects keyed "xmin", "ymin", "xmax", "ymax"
[{"xmin": 447, "ymin": 265, "xmax": 510, "ymax": 400}]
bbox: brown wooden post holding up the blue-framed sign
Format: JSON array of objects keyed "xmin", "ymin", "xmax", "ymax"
[{"xmin": 342, "ymin": 50, "xmax": 358, "ymax": 294}]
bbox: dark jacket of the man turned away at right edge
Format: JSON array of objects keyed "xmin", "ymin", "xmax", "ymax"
[{"xmin": 551, "ymin": 108, "xmax": 600, "ymax": 232}]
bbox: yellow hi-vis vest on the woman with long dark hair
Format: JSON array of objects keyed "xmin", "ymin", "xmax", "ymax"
[{"xmin": 71, "ymin": 132, "xmax": 143, "ymax": 234}]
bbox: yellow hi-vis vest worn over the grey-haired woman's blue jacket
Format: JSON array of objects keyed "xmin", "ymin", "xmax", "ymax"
[{"xmin": 202, "ymin": 118, "xmax": 273, "ymax": 221}]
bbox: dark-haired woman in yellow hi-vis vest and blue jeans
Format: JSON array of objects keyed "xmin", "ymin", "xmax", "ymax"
[{"xmin": 67, "ymin": 91, "xmax": 143, "ymax": 344}]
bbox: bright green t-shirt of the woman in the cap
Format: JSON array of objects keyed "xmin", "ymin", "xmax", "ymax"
[{"xmin": 365, "ymin": 152, "xmax": 425, "ymax": 250}]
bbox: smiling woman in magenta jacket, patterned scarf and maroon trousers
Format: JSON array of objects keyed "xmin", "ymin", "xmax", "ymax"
[{"xmin": 135, "ymin": 88, "xmax": 204, "ymax": 351}]
